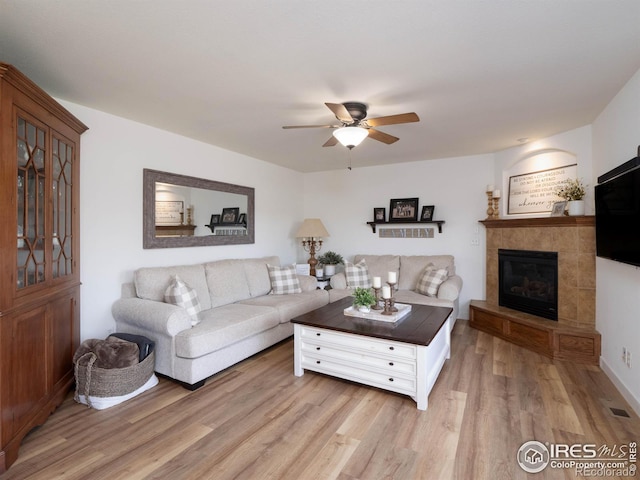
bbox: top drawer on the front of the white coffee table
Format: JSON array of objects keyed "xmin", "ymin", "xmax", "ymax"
[{"xmin": 302, "ymin": 325, "xmax": 416, "ymax": 360}]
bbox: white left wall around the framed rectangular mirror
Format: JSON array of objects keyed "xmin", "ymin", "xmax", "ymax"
[{"xmin": 60, "ymin": 101, "xmax": 303, "ymax": 340}]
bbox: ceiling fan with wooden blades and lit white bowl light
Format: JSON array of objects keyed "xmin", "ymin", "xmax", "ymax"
[{"xmin": 282, "ymin": 102, "xmax": 420, "ymax": 150}]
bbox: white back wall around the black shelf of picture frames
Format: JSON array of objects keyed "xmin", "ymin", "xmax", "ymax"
[{"xmin": 299, "ymin": 155, "xmax": 494, "ymax": 318}]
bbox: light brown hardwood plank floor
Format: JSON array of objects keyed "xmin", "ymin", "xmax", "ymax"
[{"xmin": 2, "ymin": 321, "xmax": 640, "ymax": 480}]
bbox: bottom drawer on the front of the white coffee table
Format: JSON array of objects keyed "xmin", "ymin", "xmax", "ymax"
[{"xmin": 302, "ymin": 355, "xmax": 416, "ymax": 396}]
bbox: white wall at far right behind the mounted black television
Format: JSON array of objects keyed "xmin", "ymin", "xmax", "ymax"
[{"xmin": 593, "ymin": 66, "xmax": 640, "ymax": 413}]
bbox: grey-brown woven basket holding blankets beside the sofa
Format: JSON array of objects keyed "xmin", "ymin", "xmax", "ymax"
[{"xmin": 74, "ymin": 351, "xmax": 156, "ymax": 406}]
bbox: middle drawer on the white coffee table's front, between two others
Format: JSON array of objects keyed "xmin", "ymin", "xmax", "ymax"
[{"xmin": 302, "ymin": 341, "xmax": 416, "ymax": 376}]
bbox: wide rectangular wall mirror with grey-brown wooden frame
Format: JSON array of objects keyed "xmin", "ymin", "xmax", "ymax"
[{"xmin": 142, "ymin": 168, "xmax": 255, "ymax": 248}]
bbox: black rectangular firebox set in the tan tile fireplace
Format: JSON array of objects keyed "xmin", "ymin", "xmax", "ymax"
[{"xmin": 498, "ymin": 249, "xmax": 558, "ymax": 321}]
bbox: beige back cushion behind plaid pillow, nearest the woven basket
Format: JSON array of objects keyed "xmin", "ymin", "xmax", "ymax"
[{"xmin": 133, "ymin": 264, "xmax": 211, "ymax": 310}]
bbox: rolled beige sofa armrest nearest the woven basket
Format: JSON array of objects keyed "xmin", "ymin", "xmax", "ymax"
[{"xmin": 111, "ymin": 298, "xmax": 191, "ymax": 337}]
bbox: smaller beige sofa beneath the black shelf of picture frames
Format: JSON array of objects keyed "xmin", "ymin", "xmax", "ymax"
[{"xmin": 329, "ymin": 255, "xmax": 462, "ymax": 328}]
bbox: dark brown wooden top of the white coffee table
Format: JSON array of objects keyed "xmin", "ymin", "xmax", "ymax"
[{"xmin": 291, "ymin": 297, "xmax": 453, "ymax": 346}]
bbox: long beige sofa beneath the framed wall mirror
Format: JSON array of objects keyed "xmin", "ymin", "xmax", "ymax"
[{"xmin": 112, "ymin": 256, "xmax": 329, "ymax": 389}]
